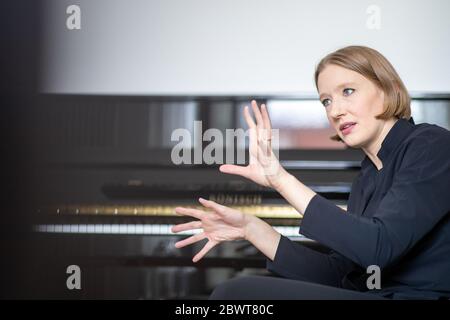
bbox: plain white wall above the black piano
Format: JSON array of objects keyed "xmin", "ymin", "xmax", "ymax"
[{"xmin": 42, "ymin": 0, "xmax": 450, "ymax": 95}]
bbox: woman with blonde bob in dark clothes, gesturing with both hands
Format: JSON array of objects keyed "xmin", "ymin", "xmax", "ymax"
[{"xmin": 173, "ymin": 46, "xmax": 450, "ymax": 299}]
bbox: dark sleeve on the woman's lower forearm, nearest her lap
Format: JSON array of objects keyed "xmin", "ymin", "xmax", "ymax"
[{"xmin": 266, "ymin": 236, "xmax": 355, "ymax": 287}]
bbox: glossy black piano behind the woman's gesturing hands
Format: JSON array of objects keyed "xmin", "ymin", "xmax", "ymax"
[{"xmin": 31, "ymin": 94, "xmax": 362, "ymax": 299}]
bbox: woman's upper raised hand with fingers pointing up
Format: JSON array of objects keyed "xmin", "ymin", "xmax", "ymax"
[{"xmin": 219, "ymin": 100, "xmax": 287, "ymax": 189}]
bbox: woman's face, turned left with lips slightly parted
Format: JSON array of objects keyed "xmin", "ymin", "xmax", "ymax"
[{"xmin": 317, "ymin": 64, "xmax": 386, "ymax": 148}]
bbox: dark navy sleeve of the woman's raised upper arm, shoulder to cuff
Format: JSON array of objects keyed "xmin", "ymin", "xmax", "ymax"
[{"xmin": 301, "ymin": 136, "xmax": 450, "ymax": 268}]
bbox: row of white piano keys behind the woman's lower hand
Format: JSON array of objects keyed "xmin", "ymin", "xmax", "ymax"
[{"xmin": 34, "ymin": 224, "xmax": 305, "ymax": 238}]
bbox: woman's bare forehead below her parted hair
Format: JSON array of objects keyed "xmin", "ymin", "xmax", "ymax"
[{"xmin": 317, "ymin": 64, "xmax": 369, "ymax": 94}]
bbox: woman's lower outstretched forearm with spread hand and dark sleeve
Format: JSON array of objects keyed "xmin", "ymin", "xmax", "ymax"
[{"xmin": 172, "ymin": 199, "xmax": 355, "ymax": 286}]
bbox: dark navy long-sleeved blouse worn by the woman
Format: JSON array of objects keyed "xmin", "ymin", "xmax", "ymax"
[{"xmin": 267, "ymin": 118, "xmax": 450, "ymax": 298}]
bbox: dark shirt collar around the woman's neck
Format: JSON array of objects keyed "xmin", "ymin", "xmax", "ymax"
[{"xmin": 361, "ymin": 117, "xmax": 415, "ymax": 169}]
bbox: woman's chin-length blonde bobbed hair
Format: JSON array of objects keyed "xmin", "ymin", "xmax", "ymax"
[{"xmin": 314, "ymin": 46, "xmax": 411, "ymax": 141}]
